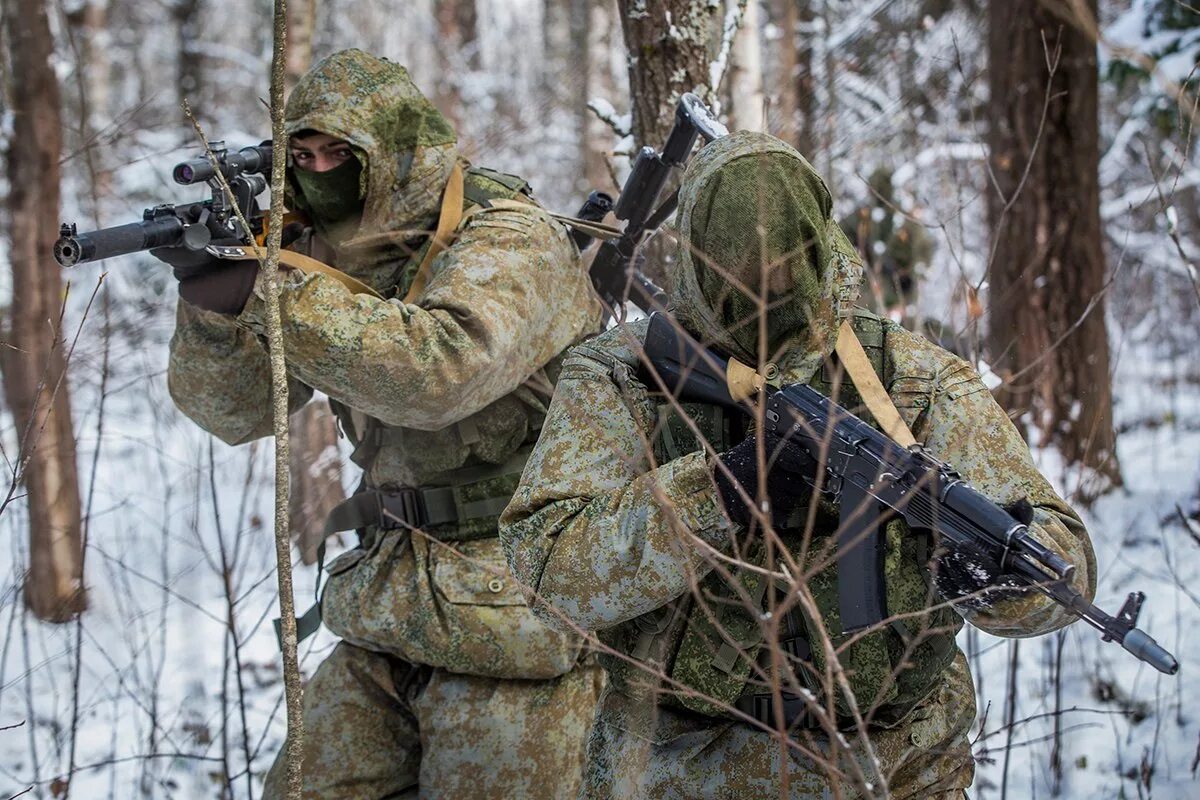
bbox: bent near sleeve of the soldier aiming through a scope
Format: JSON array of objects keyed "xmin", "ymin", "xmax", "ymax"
[{"xmin": 232, "ymin": 207, "xmax": 599, "ymax": 431}]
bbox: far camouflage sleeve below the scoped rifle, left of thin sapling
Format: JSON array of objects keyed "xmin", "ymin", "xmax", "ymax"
[{"xmin": 167, "ymin": 300, "xmax": 312, "ymax": 445}]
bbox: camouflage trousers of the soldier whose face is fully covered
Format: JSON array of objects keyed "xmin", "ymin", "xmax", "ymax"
[{"xmin": 580, "ymin": 652, "xmax": 976, "ymax": 800}]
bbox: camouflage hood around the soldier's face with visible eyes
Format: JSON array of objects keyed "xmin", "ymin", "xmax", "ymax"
[{"xmin": 284, "ymin": 49, "xmax": 458, "ymax": 277}]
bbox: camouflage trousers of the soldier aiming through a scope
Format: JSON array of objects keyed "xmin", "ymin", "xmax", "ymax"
[{"xmin": 263, "ymin": 642, "xmax": 604, "ymax": 800}]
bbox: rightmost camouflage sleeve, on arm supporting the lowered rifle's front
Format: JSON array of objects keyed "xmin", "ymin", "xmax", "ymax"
[{"xmin": 892, "ymin": 335, "xmax": 1096, "ymax": 637}]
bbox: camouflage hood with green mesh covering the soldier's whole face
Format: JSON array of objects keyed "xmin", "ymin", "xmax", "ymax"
[{"xmin": 668, "ymin": 131, "xmax": 862, "ymax": 380}]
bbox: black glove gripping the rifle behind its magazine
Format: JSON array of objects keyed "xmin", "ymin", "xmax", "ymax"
[{"xmin": 713, "ymin": 433, "xmax": 816, "ymax": 529}]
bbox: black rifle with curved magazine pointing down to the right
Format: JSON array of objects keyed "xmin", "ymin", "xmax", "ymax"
[{"xmin": 644, "ymin": 313, "xmax": 1180, "ymax": 675}]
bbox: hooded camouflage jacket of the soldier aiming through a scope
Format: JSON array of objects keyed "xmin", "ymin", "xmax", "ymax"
[{"xmin": 168, "ymin": 50, "xmax": 600, "ymax": 678}]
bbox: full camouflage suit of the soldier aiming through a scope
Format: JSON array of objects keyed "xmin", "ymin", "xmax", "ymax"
[{"xmin": 168, "ymin": 50, "xmax": 602, "ymax": 800}]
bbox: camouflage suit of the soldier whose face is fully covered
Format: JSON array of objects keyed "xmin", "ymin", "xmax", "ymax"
[{"xmin": 500, "ymin": 133, "xmax": 1096, "ymax": 798}]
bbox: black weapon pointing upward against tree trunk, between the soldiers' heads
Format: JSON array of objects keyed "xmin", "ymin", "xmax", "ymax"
[{"xmin": 589, "ymin": 92, "xmax": 728, "ymax": 311}]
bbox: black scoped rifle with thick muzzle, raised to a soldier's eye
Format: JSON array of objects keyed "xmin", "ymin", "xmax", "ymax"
[{"xmin": 54, "ymin": 142, "xmax": 271, "ymax": 266}]
